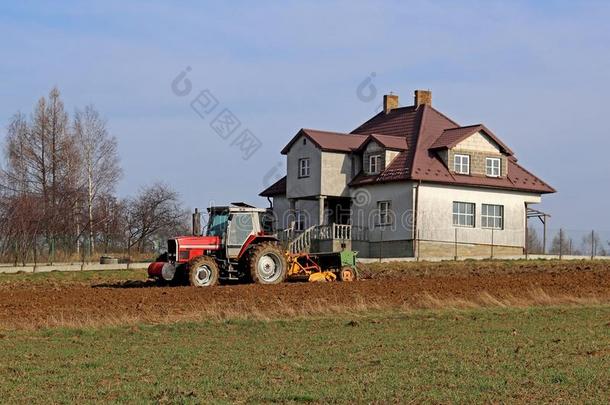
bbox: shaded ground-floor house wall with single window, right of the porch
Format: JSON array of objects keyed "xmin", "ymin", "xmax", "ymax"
[{"xmin": 351, "ymin": 182, "xmax": 413, "ymax": 242}]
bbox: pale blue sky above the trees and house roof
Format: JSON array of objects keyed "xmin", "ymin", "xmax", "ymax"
[{"xmin": 0, "ymin": 0, "xmax": 610, "ymax": 234}]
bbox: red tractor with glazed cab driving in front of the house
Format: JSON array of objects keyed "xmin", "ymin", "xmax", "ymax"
[{"xmin": 148, "ymin": 203, "xmax": 288, "ymax": 287}]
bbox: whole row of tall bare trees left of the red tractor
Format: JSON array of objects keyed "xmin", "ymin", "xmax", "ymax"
[{"xmin": 0, "ymin": 88, "xmax": 188, "ymax": 262}]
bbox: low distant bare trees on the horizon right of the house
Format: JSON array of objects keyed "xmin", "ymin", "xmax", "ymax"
[{"xmin": 527, "ymin": 227, "xmax": 608, "ymax": 256}]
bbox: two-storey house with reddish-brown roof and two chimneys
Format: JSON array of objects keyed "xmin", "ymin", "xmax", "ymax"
[{"xmin": 260, "ymin": 90, "xmax": 555, "ymax": 257}]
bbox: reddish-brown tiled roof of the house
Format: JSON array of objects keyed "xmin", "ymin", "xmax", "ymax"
[{"xmin": 268, "ymin": 104, "xmax": 555, "ymax": 195}]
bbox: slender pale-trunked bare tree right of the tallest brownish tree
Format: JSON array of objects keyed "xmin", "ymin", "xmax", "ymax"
[{"xmin": 74, "ymin": 105, "xmax": 121, "ymax": 254}]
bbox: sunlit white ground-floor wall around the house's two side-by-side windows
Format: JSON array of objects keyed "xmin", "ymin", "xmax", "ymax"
[{"xmin": 417, "ymin": 184, "xmax": 541, "ymax": 247}]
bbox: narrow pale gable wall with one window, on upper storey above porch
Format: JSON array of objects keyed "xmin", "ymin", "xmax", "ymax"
[{"xmin": 286, "ymin": 135, "xmax": 322, "ymax": 198}]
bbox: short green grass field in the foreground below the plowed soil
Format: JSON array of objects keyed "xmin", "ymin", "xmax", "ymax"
[{"xmin": 0, "ymin": 305, "xmax": 610, "ymax": 403}]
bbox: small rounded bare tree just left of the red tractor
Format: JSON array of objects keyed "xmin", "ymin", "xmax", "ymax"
[{"xmin": 126, "ymin": 183, "xmax": 188, "ymax": 252}]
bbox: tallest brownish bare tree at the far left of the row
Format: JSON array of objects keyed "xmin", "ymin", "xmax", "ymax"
[{"xmin": 2, "ymin": 88, "xmax": 80, "ymax": 260}]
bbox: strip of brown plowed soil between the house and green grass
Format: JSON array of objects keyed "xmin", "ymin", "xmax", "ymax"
[{"xmin": 0, "ymin": 262, "xmax": 610, "ymax": 328}]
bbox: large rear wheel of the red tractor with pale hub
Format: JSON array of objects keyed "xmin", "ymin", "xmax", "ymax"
[{"xmin": 248, "ymin": 243, "xmax": 288, "ymax": 284}]
